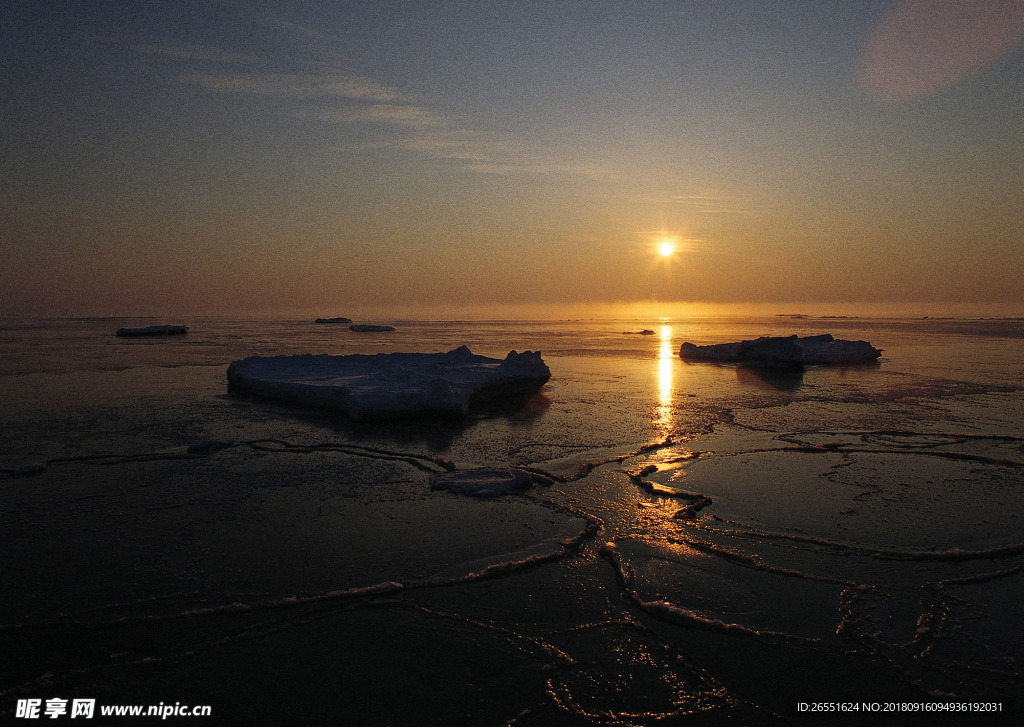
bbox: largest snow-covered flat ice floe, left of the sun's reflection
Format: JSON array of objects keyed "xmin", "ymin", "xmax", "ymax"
[{"xmin": 227, "ymin": 346, "xmax": 551, "ymax": 419}]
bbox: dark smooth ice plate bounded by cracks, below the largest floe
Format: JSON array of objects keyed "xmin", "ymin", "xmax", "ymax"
[{"xmin": 0, "ymin": 446, "xmax": 587, "ymax": 622}]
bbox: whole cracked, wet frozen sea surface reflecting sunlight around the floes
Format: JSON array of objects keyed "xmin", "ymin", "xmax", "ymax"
[{"xmin": 0, "ymin": 324, "xmax": 1024, "ymax": 725}]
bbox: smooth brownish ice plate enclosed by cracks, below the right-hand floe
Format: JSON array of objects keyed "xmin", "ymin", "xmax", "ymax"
[{"xmin": 663, "ymin": 451, "xmax": 1024, "ymax": 549}]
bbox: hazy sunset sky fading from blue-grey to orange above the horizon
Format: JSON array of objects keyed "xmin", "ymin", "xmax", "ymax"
[{"xmin": 0, "ymin": 0, "xmax": 1024, "ymax": 317}]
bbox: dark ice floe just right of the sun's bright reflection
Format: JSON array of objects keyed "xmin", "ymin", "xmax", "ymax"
[{"xmin": 679, "ymin": 333, "xmax": 882, "ymax": 366}]
